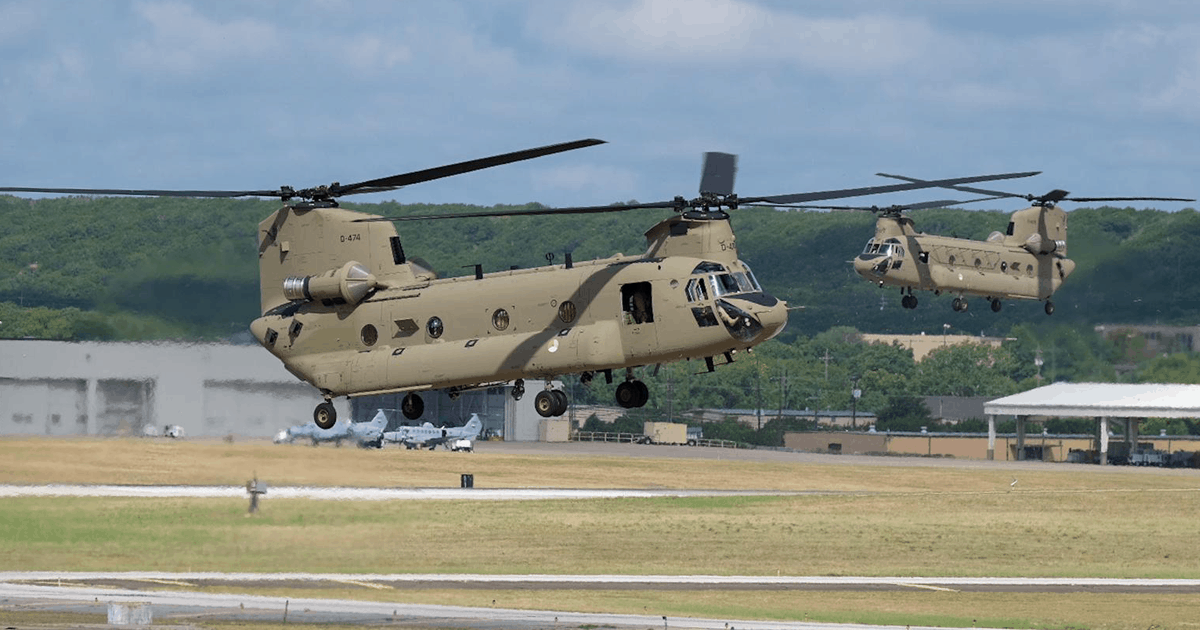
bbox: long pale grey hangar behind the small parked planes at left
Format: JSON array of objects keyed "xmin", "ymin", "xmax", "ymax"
[{"xmin": 0, "ymin": 340, "xmax": 546, "ymax": 442}]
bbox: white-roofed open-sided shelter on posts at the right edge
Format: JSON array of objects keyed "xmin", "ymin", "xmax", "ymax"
[{"xmin": 983, "ymin": 383, "xmax": 1200, "ymax": 464}]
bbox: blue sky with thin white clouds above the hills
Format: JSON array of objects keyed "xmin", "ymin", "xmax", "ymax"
[{"xmin": 0, "ymin": 0, "xmax": 1200, "ymax": 210}]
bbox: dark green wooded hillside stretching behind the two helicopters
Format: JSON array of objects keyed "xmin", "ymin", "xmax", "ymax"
[{"xmin": 0, "ymin": 196, "xmax": 1200, "ymax": 338}]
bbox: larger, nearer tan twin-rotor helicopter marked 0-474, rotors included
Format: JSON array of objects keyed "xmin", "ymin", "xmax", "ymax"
[{"xmin": 0, "ymin": 139, "xmax": 1034, "ymax": 427}]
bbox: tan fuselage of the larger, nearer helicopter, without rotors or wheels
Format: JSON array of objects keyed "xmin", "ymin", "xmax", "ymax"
[{"xmin": 251, "ymin": 209, "xmax": 787, "ymax": 403}]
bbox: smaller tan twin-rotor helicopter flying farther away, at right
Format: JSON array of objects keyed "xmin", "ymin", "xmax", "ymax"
[{"xmin": 782, "ymin": 173, "xmax": 1195, "ymax": 314}]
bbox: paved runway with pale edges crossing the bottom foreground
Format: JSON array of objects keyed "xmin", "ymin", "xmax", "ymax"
[{"xmin": 9, "ymin": 571, "xmax": 1200, "ymax": 630}]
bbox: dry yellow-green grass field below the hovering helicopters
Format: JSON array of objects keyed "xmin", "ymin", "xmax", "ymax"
[{"xmin": 0, "ymin": 439, "xmax": 1200, "ymax": 630}]
